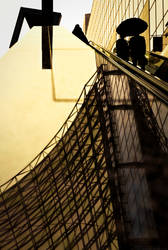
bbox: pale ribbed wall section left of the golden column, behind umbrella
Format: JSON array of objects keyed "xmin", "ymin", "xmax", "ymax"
[{"xmin": 87, "ymin": 0, "xmax": 146, "ymax": 47}]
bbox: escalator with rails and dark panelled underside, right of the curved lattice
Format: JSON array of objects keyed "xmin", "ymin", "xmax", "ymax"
[{"xmin": 90, "ymin": 42, "xmax": 168, "ymax": 250}]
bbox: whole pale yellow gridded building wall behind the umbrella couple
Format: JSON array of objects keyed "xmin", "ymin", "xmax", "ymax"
[{"xmin": 86, "ymin": 0, "xmax": 168, "ymax": 54}]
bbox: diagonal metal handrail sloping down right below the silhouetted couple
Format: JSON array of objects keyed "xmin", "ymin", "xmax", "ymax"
[{"xmin": 89, "ymin": 41, "xmax": 168, "ymax": 105}]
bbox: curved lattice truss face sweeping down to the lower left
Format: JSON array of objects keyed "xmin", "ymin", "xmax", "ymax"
[{"xmin": 0, "ymin": 67, "xmax": 119, "ymax": 249}]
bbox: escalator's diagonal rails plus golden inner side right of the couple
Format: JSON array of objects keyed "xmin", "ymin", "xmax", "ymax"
[{"xmin": 90, "ymin": 41, "xmax": 168, "ymax": 103}]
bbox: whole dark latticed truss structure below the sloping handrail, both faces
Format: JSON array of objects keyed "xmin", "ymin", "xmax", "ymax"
[{"xmin": 0, "ymin": 49, "xmax": 168, "ymax": 250}]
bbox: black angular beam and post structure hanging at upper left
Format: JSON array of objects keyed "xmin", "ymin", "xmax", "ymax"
[{"xmin": 9, "ymin": 0, "xmax": 62, "ymax": 69}]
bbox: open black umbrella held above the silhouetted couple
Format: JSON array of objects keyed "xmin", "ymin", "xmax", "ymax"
[{"xmin": 116, "ymin": 17, "xmax": 148, "ymax": 36}]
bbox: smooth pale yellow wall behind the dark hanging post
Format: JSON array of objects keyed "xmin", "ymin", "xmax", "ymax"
[{"xmin": 0, "ymin": 26, "xmax": 96, "ymax": 184}]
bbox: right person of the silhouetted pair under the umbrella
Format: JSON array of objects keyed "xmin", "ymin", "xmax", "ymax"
[{"xmin": 129, "ymin": 34, "xmax": 147, "ymax": 70}]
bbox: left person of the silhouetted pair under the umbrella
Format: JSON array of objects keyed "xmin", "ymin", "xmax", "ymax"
[{"xmin": 116, "ymin": 35, "xmax": 129, "ymax": 61}]
